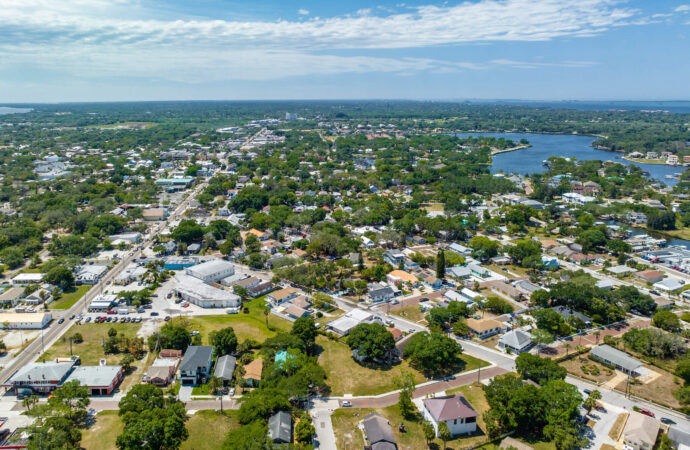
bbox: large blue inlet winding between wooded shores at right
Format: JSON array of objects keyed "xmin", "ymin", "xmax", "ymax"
[{"xmin": 457, "ymin": 133, "xmax": 684, "ymax": 186}]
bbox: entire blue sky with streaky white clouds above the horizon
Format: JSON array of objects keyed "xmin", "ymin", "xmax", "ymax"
[{"xmin": 0, "ymin": 0, "xmax": 690, "ymax": 103}]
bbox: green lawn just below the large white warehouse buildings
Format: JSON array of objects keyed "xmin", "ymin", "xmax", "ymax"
[{"xmin": 171, "ymin": 298, "xmax": 292, "ymax": 344}]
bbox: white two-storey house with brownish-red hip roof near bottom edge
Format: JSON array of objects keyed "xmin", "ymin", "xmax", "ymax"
[{"xmin": 422, "ymin": 394, "xmax": 479, "ymax": 437}]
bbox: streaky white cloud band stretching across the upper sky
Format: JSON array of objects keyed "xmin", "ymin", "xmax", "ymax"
[{"xmin": 0, "ymin": 0, "xmax": 639, "ymax": 83}]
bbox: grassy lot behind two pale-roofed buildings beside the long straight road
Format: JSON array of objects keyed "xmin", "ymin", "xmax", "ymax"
[{"xmin": 41, "ymin": 323, "xmax": 141, "ymax": 366}]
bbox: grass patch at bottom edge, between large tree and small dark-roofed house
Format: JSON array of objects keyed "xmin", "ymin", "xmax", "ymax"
[{"xmin": 180, "ymin": 410, "xmax": 240, "ymax": 450}]
